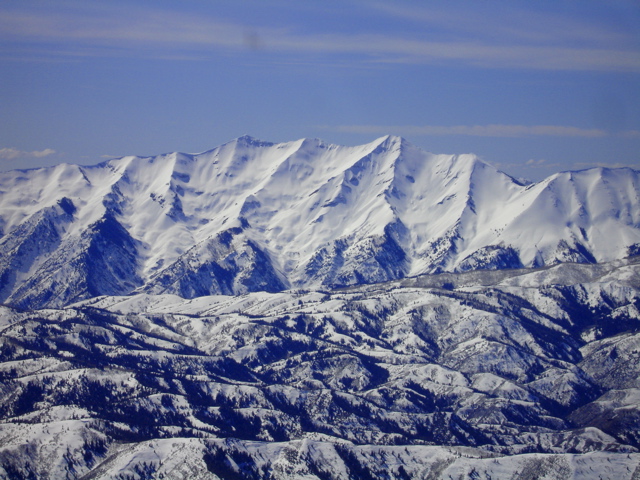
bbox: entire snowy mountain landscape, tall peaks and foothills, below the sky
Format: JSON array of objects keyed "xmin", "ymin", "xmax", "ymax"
[{"xmin": 0, "ymin": 137, "xmax": 640, "ymax": 480}]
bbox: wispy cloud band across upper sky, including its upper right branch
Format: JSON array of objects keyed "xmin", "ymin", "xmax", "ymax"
[{"xmin": 0, "ymin": 6, "xmax": 640, "ymax": 72}]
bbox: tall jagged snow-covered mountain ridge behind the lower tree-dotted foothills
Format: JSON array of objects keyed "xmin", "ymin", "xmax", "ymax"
[{"xmin": 0, "ymin": 137, "xmax": 640, "ymax": 309}]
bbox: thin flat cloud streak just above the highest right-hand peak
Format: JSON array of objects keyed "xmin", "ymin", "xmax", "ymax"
[{"xmin": 323, "ymin": 125, "xmax": 608, "ymax": 138}]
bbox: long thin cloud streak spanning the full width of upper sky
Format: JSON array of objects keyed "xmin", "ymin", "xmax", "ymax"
[{"xmin": 0, "ymin": 9, "xmax": 640, "ymax": 72}]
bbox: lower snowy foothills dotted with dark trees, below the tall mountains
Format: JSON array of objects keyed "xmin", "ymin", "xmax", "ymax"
[{"xmin": 0, "ymin": 259, "xmax": 640, "ymax": 480}]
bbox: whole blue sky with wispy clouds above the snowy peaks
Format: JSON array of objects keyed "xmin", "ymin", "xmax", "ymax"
[{"xmin": 0, "ymin": 0, "xmax": 640, "ymax": 180}]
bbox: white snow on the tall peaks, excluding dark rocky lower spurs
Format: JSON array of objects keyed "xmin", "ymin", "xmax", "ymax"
[{"xmin": 0, "ymin": 136, "xmax": 640, "ymax": 306}]
